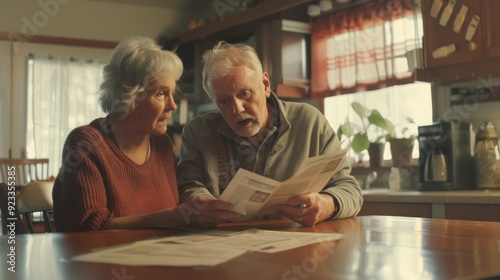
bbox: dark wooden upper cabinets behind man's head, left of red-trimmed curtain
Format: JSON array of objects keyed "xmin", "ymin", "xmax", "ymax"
[{"xmin": 161, "ymin": 0, "xmax": 312, "ymax": 109}]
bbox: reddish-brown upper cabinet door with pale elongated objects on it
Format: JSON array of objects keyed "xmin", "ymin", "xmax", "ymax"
[{"xmin": 422, "ymin": 0, "xmax": 484, "ymax": 68}]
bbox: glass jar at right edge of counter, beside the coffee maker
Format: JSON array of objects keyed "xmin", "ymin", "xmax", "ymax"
[{"xmin": 474, "ymin": 122, "xmax": 500, "ymax": 189}]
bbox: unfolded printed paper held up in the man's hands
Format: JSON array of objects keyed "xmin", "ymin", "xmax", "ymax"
[{"xmin": 219, "ymin": 147, "xmax": 349, "ymax": 221}]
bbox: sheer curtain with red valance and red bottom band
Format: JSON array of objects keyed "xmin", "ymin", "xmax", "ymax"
[{"xmin": 311, "ymin": 0, "xmax": 423, "ymax": 98}]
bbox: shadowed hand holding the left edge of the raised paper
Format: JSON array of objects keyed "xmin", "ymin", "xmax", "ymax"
[{"xmin": 179, "ymin": 196, "xmax": 240, "ymax": 228}]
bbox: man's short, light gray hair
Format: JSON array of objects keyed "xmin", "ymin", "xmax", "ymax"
[{"xmin": 203, "ymin": 41, "xmax": 263, "ymax": 100}]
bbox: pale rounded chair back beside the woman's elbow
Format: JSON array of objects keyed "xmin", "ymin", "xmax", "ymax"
[{"xmin": 16, "ymin": 181, "xmax": 54, "ymax": 214}]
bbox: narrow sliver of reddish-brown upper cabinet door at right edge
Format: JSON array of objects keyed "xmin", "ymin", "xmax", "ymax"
[{"xmin": 477, "ymin": 0, "xmax": 500, "ymax": 57}]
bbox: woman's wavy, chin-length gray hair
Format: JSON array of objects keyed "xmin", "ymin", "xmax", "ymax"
[{"xmin": 99, "ymin": 36, "xmax": 184, "ymax": 114}]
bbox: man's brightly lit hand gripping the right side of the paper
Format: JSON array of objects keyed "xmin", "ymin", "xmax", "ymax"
[{"xmin": 276, "ymin": 193, "xmax": 336, "ymax": 226}]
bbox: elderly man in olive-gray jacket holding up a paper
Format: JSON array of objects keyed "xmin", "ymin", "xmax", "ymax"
[{"xmin": 177, "ymin": 42, "xmax": 363, "ymax": 227}]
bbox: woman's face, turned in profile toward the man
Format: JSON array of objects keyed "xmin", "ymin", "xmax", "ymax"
[{"xmin": 131, "ymin": 78, "xmax": 177, "ymax": 135}]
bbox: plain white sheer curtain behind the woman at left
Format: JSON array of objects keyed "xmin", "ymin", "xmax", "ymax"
[{"xmin": 27, "ymin": 55, "xmax": 105, "ymax": 176}]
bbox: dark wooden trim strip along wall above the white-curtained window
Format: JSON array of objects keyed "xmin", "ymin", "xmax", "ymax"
[{"xmin": 0, "ymin": 32, "xmax": 118, "ymax": 49}]
